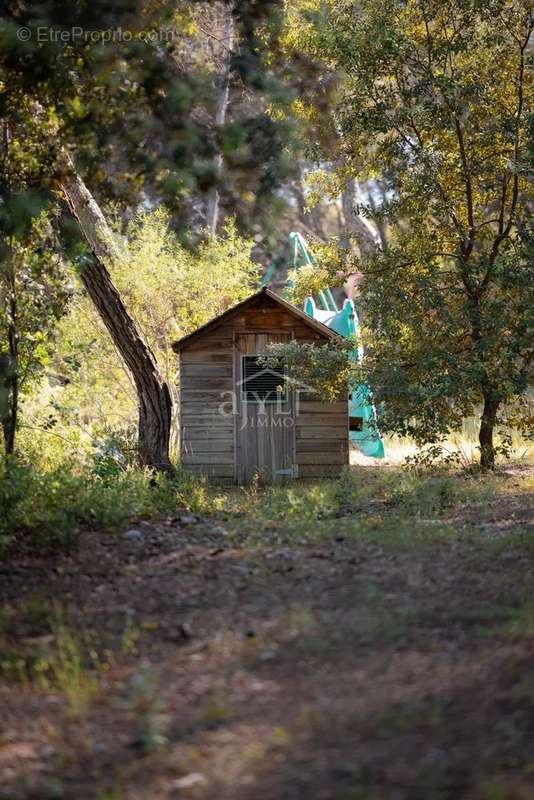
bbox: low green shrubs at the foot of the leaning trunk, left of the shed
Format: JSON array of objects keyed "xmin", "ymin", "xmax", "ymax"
[{"xmin": 0, "ymin": 459, "xmax": 224, "ymax": 555}]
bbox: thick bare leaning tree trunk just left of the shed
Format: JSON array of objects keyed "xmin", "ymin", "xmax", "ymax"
[{"xmin": 59, "ymin": 156, "xmax": 172, "ymax": 470}]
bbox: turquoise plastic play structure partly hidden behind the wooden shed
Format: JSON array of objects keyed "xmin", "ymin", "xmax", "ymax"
[{"xmin": 263, "ymin": 232, "xmax": 384, "ymax": 458}]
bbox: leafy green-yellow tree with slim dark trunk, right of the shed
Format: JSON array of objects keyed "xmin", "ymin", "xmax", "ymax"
[{"xmin": 288, "ymin": 0, "xmax": 534, "ymax": 466}]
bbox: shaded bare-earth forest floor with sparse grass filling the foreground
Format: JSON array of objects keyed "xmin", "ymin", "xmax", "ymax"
[{"xmin": 0, "ymin": 466, "xmax": 534, "ymax": 800}]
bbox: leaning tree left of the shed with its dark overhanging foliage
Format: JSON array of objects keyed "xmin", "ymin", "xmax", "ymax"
[{"xmin": 0, "ymin": 0, "xmax": 300, "ymax": 469}]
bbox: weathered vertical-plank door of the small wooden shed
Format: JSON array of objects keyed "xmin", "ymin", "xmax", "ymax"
[{"xmin": 235, "ymin": 333, "xmax": 296, "ymax": 484}]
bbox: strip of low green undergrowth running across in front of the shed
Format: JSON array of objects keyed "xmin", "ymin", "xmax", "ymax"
[{"xmin": 0, "ymin": 446, "xmax": 528, "ymax": 557}]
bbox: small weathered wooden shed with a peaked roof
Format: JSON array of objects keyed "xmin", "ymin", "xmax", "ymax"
[{"xmin": 173, "ymin": 289, "xmax": 349, "ymax": 484}]
